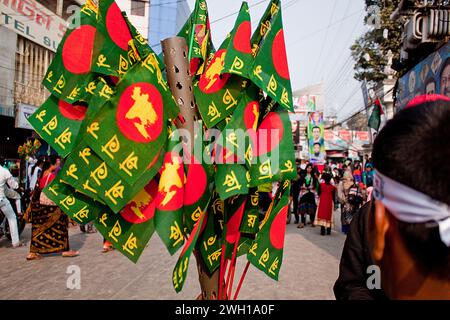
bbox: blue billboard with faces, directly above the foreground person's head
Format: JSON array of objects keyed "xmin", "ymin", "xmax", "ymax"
[{"xmin": 395, "ymin": 42, "xmax": 450, "ymax": 110}]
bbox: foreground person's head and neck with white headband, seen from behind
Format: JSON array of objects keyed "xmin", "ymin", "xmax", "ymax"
[{"xmin": 369, "ymin": 95, "xmax": 450, "ymax": 298}]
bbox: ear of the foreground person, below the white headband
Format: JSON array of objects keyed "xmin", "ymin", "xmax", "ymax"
[{"xmin": 372, "ymin": 200, "xmax": 389, "ymax": 263}]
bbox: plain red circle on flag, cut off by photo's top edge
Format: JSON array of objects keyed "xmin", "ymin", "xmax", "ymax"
[{"xmin": 106, "ymin": 2, "xmax": 132, "ymax": 51}]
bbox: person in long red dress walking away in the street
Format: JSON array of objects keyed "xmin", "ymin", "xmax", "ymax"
[{"xmin": 315, "ymin": 173, "xmax": 336, "ymax": 236}]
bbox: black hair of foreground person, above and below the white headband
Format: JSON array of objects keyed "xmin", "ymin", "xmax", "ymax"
[{"xmin": 372, "ymin": 100, "xmax": 450, "ymax": 281}]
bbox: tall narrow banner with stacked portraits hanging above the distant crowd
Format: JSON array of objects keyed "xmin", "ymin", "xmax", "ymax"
[{"xmin": 308, "ymin": 112, "xmax": 326, "ymax": 165}]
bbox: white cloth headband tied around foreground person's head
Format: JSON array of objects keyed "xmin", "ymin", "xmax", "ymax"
[{"xmin": 373, "ymin": 170, "xmax": 450, "ymax": 247}]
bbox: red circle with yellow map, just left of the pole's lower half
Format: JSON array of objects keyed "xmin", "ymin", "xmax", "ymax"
[{"xmin": 156, "ymin": 152, "xmax": 184, "ymax": 211}]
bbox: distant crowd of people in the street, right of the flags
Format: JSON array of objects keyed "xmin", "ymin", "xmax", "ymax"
[{"xmin": 287, "ymin": 155, "xmax": 373, "ymax": 235}]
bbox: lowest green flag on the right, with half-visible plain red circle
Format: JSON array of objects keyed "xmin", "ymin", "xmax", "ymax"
[{"xmin": 247, "ymin": 181, "xmax": 290, "ymax": 280}]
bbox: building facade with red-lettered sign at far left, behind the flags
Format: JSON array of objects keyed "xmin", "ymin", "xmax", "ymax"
[{"xmin": 0, "ymin": 0, "xmax": 83, "ymax": 158}]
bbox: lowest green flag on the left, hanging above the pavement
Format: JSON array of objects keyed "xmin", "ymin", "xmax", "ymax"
[{"xmin": 95, "ymin": 180, "xmax": 158, "ymax": 263}]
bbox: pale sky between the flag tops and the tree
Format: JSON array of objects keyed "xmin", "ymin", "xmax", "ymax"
[{"xmin": 188, "ymin": 0, "xmax": 367, "ymax": 120}]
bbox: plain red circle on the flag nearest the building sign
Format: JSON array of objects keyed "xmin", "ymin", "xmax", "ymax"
[{"xmin": 61, "ymin": 25, "xmax": 96, "ymax": 74}]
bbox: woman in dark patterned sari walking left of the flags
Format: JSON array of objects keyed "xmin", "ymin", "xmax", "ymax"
[{"xmin": 27, "ymin": 157, "xmax": 79, "ymax": 260}]
